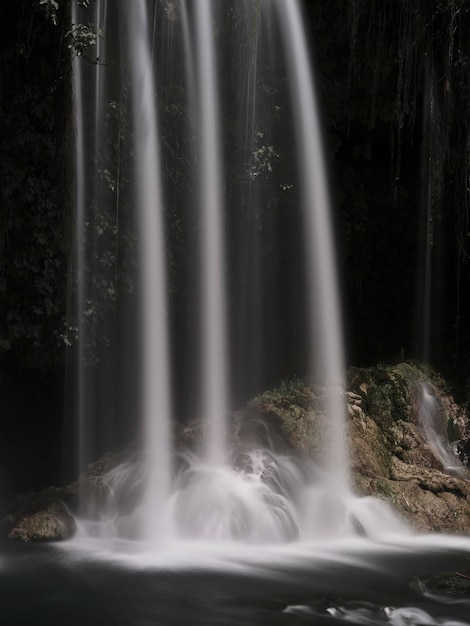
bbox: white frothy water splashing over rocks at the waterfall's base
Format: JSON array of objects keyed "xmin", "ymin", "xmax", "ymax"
[{"xmin": 73, "ymin": 448, "xmax": 411, "ymax": 540}]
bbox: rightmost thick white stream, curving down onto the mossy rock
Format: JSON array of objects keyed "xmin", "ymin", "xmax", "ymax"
[{"xmin": 276, "ymin": 0, "xmax": 349, "ymax": 492}]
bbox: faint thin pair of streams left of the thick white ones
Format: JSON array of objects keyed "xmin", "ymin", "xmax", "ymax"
[{"xmin": 73, "ymin": 0, "xmax": 118, "ymax": 469}]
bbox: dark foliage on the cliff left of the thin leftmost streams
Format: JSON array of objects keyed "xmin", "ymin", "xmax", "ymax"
[{"xmin": 0, "ymin": 0, "xmax": 73, "ymax": 368}]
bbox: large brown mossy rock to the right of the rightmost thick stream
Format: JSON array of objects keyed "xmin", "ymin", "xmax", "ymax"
[{"xmin": 349, "ymin": 363, "xmax": 470, "ymax": 534}]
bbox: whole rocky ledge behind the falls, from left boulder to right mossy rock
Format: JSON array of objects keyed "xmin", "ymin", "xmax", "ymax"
[{"xmin": 0, "ymin": 363, "xmax": 470, "ymax": 541}]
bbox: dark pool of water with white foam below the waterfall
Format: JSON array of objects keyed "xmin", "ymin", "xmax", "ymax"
[{"xmin": 0, "ymin": 536, "xmax": 470, "ymax": 626}]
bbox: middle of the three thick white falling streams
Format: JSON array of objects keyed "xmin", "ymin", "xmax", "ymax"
[{"xmin": 196, "ymin": 0, "xmax": 228, "ymax": 465}]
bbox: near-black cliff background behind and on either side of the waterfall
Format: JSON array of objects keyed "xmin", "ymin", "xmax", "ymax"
[{"xmin": 0, "ymin": 0, "xmax": 470, "ymax": 504}]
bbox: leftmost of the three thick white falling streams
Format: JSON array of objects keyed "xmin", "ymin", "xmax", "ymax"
[{"xmin": 124, "ymin": 0, "xmax": 172, "ymax": 541}]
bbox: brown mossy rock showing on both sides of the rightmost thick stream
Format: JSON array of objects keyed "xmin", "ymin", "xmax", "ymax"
[{"xmin": 252, "ymin": 363, "xmax": 470, "ymax": 535}]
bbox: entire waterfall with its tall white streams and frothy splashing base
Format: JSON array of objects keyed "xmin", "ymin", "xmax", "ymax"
[{"xmin": 71, "ymin": 0, "xmax": 364, "ymax": 543}]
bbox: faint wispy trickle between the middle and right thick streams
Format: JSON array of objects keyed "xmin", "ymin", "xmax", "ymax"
[{"xmin": 232, "ymin": 2, "xmax": 266, "ymax": 393}]
